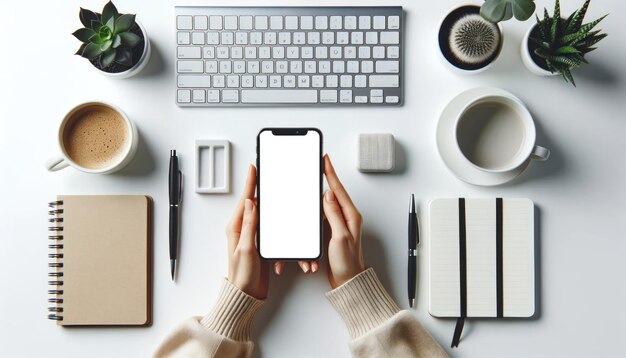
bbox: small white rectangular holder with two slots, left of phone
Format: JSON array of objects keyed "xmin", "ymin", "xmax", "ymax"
[{"xmin": 196, "ymin": 140, "xmax": 230, "ymax": 194}]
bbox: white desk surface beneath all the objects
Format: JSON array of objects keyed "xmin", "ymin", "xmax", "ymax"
[{"xmin": 0, "ymin": 0, "xmax": 626, "ymax": 357}]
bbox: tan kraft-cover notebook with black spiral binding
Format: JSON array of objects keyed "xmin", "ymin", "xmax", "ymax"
[{"xmin": 48, "ymin": 195, "xmax": 152, "ymax": 326}]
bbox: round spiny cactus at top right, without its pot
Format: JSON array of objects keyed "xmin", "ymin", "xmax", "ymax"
[{"xmin": 449, "ymin": 14, "xmax": 500, "ymax": 65}]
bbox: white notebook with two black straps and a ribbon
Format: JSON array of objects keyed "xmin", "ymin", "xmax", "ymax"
[{"xmin": 429, "ymin": 198, "xmax": 535, "ymax": 346}]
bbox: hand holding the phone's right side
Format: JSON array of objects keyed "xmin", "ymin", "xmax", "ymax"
[{"xmin": 323, "ymin": 155, "xmax": 365, "ymax": 289}]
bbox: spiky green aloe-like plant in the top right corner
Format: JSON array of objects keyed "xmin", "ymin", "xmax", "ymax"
[{"xmin": 530, "ymin": 0, "xmax": 608, "ymax": 87}]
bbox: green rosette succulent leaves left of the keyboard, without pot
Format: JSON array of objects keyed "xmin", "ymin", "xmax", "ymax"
[{"xmin": 72, "ymin": 1, "xmax": 141, "ymax": 68}]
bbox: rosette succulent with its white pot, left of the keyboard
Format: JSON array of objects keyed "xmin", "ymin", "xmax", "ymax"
[{"xmin": 73, "ymin": 1, "xmax": 150, "ymax": 78}]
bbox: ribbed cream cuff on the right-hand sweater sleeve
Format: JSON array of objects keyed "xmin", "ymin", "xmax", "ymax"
[{"xmin": 326, "ymin": 268, "xmax": 400, "ymax": 339}]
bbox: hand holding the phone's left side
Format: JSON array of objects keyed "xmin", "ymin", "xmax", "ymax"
[{"xmin": 226, "ymin": 165, "xmax": 269, "ymax": 299}]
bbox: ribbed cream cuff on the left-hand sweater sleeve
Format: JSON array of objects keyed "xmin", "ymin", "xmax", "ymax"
[{"xmin": 200, "ymin": 279, "xmax": 265, "ymax": 342}]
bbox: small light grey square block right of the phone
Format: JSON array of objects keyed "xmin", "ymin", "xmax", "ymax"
[{"xmin": 357, "ymin": 133, "xmax": 396, "ymax": 173}]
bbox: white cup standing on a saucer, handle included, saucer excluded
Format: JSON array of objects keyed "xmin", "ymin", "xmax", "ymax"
[{"xmin": 453, "ymin": 95, "xmax": 550, "ymax": 173}]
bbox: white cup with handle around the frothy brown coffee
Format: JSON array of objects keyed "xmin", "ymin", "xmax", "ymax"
[{"xmin": 46, "ymin": 101, "xmax": 139, "ymax": 174}]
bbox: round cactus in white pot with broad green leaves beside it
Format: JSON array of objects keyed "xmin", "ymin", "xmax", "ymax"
[{"xmin": 439, "ymin": 0, "xmax": 535, "ymax": 73}]
